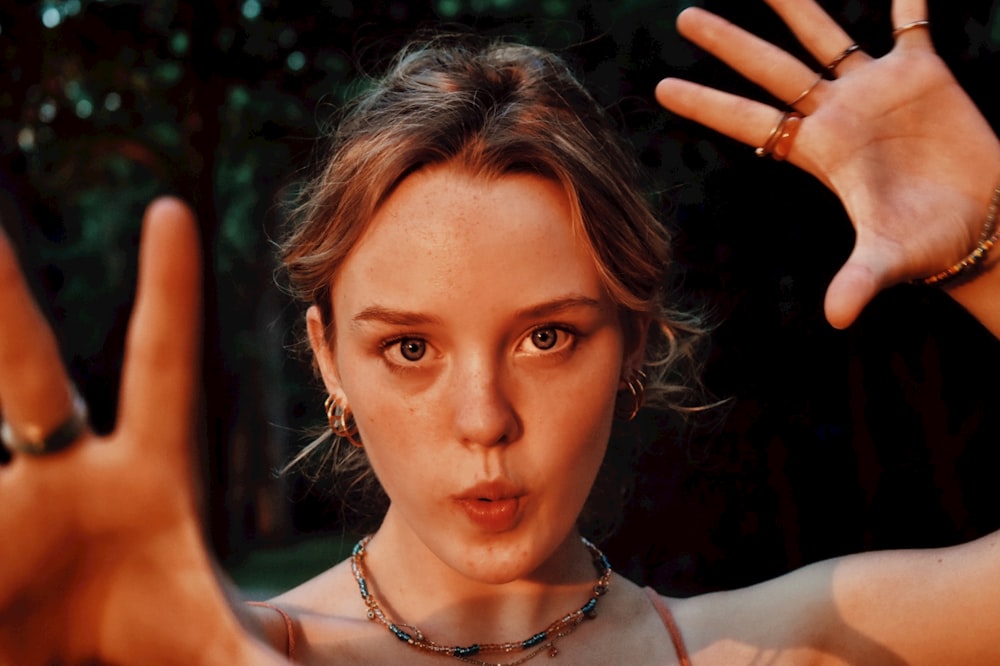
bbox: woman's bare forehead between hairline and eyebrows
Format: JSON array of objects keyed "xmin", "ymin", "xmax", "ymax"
[{"xmin": 334, "ymin": 164, "xmax": 605, "ymax": 316}]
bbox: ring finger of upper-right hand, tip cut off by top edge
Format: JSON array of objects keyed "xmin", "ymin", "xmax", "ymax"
[{"xmin": 766, "ymin": 0, "xmax": 871, "ymax": 75}]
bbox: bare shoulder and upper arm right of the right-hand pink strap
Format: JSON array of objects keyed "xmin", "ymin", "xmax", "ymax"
[{"xmin": 669, "ymin": 534, "xmax": 1000, "ymax": 666}]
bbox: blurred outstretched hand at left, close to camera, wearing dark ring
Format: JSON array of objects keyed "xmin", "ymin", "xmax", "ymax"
[{"xmin": 0, "ymin": 199, "xmax": 280, "ymax": 665}]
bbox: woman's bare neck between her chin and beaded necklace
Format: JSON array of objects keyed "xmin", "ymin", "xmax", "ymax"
[{"xmin": 364, "ymin": 511, "xmax": 599, "ymax": 645}]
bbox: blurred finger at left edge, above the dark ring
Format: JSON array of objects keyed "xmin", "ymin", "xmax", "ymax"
[{"xmin": 0, "ymin": 224, "xmax": 74, "ymax": 452}]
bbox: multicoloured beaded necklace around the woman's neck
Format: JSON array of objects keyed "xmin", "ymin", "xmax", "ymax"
[{"xmin": 351, "ymin": 535, "xmax": 611, "ymax": 666}]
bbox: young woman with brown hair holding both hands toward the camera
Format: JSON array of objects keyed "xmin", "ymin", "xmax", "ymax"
[{"xmin": 0, "ymin": 0, "xmax": 1000, "ymax": 665}]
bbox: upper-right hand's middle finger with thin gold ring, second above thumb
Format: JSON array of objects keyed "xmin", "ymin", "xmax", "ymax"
[{"xmin": 677, "ymin": 7, "xmax": 826, "ymax": 111}]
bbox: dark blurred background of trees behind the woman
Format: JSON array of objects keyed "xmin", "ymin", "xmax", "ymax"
[{"xmin": 0, "ymin": 0, "xmax": 1000, "ymax": 595}]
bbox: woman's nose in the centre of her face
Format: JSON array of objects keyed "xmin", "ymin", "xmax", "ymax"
[{"xmin": 451, "ymin": 359, "xmax": 520, "ymax": 446}]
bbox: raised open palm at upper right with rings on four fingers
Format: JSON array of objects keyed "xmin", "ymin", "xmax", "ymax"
[{"xmin": 656, "ymin": 0, "xmax": 1000, "ymax": 328}]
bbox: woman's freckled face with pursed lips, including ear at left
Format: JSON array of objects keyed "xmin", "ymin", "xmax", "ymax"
[{"xmin": 308, "ymin": 164, "xmax": 625, "ymax": 582}]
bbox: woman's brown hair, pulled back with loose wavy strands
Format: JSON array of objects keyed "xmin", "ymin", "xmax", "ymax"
[{"xmin": 281, "ymin": 35, "xmax": 701, "ymax": 540}]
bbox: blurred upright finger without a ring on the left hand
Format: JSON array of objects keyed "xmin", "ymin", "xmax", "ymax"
[{"xmin": 118, "ymin": 198, "xmax": 201, "ymax": 459}]
